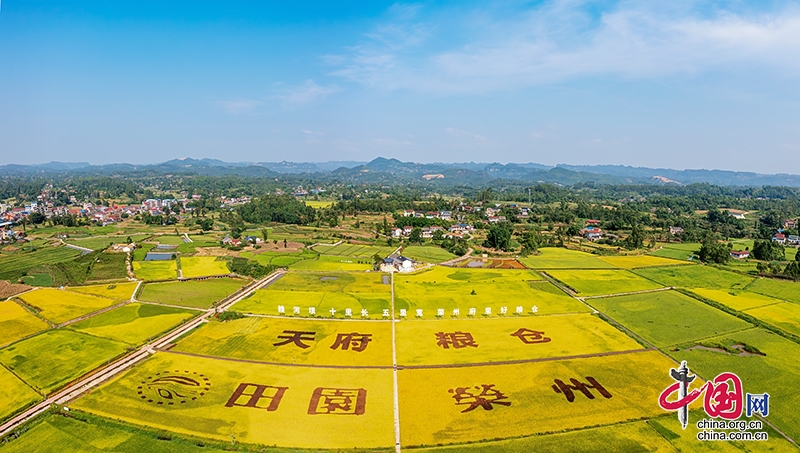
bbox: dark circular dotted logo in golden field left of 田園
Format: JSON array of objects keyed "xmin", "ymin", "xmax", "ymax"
[{"xmin": 137, "ymin": 370, "xmax": 211, "ymax": 406}]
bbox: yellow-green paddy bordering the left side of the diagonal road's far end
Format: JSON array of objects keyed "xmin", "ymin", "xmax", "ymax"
[{"xmin": 139, "ymin": 278, "xmax": 247, "ymax": 309}]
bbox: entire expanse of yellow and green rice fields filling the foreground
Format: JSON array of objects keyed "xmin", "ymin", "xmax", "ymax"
[{"xmin": 0, "ymin": 245, "xmax": 800, "ymax": 453}]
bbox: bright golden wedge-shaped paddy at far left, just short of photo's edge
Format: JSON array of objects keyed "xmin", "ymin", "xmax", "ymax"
[{"xmin": 17, "ymin": 288, "xmax": 119, "ymax": 324}]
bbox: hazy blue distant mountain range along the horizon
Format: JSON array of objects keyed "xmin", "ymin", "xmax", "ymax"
[{"xmin": 0, "ymin": 157, "xmax": 800, "ymax": 187}]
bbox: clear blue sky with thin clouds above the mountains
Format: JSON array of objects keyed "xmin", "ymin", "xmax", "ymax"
[{"xmin": 0, "ymin": 0, "xmax": 800, "ymax": 173}]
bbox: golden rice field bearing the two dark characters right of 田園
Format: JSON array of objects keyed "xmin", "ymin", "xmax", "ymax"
[{"xmin": 398, "ymin": 351, "xmax": 674, "ymax": 446}]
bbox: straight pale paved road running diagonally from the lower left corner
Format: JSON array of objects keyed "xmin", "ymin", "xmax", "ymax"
[{"xmin": 0, "ymin": 269, "xmax": 286, "ymax": 437}]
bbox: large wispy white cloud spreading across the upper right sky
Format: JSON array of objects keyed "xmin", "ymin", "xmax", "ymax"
[{"xmin": 327, "ymin": 0, "xmax": 800, "ymax": 94}]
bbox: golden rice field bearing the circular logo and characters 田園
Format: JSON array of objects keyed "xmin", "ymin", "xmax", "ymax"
[{"xmin": 72, "ymin": 353, "xmax": 394, "ymax": 449}]
